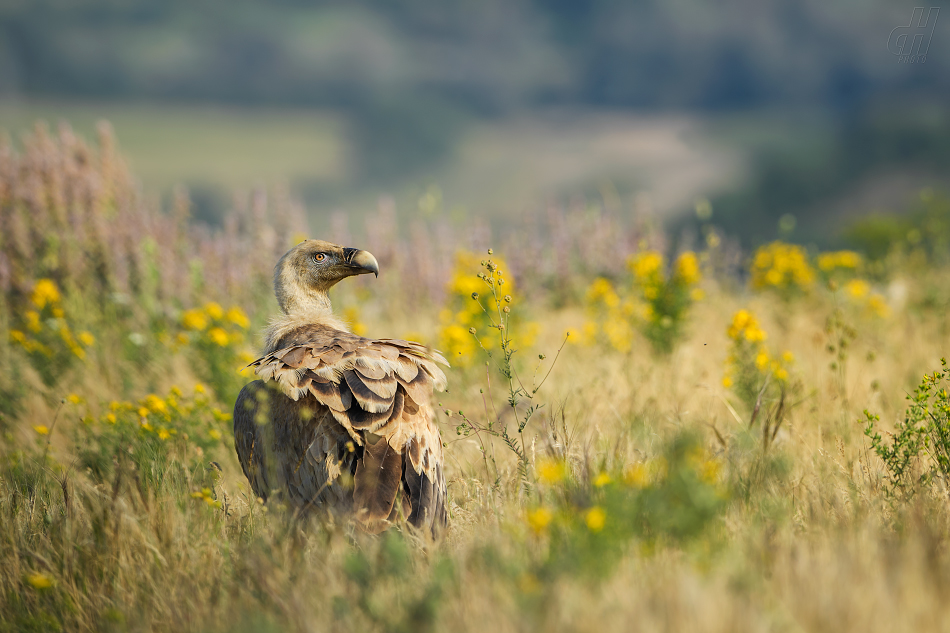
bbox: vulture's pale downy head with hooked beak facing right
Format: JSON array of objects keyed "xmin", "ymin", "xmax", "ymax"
[{"xmin": 274, "ymin": 240, "xmax": 379, "ymax": 314}]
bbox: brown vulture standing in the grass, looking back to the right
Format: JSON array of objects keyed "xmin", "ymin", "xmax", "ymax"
[{"xmin": 234, "ymin": 240, "xmax": 448, "ymax": 534}]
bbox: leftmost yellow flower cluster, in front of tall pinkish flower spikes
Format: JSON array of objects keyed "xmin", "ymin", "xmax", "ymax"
[{"xmin": 9, "ymin": 279, "xmax": 96, "ymax": 360}]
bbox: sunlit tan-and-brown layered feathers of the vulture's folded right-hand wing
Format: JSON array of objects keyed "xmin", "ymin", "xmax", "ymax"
[{"xmin": 245, "ymin": 325, "xmax": 448, "ymax": 532}]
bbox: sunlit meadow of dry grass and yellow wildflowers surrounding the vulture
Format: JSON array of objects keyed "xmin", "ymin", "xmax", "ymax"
[{"xmin": 0, "ymin": 127, "xmax": 950, "ymax": 631}]
